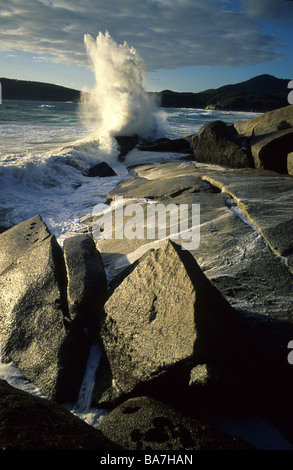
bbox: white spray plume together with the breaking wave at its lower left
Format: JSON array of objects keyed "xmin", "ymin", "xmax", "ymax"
[{"xmin": 55, "ymin": 32, "xmax": 167, "ymax": 168}]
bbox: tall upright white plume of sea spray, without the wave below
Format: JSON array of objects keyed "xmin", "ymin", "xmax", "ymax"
[{"xmin": 80, "ymin": 31, "xmax": 163, "ymax": 145}]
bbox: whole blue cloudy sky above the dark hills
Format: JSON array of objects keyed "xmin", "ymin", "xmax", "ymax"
[{"xmin": 0, "ymin": 0, "xmax": 293, "ymax": 91}]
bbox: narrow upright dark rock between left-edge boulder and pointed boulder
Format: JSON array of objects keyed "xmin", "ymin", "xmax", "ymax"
[{"xmin": 63, "ymin": 235, "xmax": 108, "ymax": 327}]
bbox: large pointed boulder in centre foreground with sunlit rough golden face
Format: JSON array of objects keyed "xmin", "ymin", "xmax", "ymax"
[{"xmin": 94, "ymin": 240, "xmax": 254, "ymax": 403}]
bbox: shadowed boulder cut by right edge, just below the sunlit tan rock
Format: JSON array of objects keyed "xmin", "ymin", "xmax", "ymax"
[{"xmin": 250, "ymin": 128, "xmax": 293, "ymax": 173}]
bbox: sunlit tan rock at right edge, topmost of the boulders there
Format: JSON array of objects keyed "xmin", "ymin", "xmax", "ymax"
[{"xmin": 234, "ymin": 105, "xmax": 293, "ymax": 137}]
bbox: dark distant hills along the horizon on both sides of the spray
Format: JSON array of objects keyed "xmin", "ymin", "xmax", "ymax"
[{"xmin": 0, "ymin": 75, "xmax": 290, "ymax": 112}]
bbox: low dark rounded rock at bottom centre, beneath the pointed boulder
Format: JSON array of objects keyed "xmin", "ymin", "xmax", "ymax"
[{"xmin": 99, "ymin": 396, "xmax": 254, "ymax": 451}]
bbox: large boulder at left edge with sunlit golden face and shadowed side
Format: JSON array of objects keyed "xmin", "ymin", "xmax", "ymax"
[{"xmin": 0, "ymin": 216, "xmax": 89, "ymax": 402}]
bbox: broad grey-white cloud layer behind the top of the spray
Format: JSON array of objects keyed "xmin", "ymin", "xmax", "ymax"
[{"xmin": 0, "ymin": 0, "xmax": 293, "ymax": 71}]
